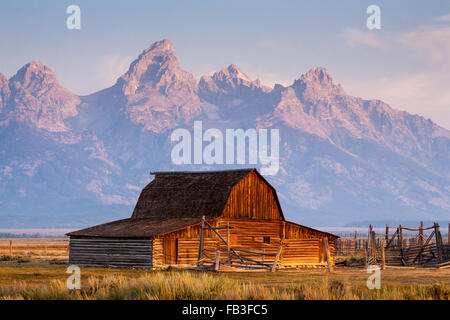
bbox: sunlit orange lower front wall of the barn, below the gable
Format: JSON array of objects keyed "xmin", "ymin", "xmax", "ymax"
[{"xmin": 153, "ymin": 218, "xmax": 335, "ymax": 267}]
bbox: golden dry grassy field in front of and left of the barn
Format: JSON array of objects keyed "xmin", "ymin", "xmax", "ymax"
[{"xmin": 0, "ymin": 239, "xmax": 450, "ymax": 300}]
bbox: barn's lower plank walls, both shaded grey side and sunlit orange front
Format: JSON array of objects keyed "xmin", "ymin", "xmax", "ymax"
[{"xmin": 70, "ymin": 218, "xmax": 335, "ymax": 268}]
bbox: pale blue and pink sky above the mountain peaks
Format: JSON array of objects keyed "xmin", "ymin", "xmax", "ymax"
[{"xmin": 0, "ymin": 0, "xmax": 450, "ymax": 129}]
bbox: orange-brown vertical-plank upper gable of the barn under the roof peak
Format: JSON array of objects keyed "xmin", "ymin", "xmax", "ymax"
[{"xmin": 222, "ymin": 172, "xmax": 282, "ymax": 220}]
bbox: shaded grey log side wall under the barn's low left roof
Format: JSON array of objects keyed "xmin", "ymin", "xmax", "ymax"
[{"xmin": 69, "ymin": 237, "xmax": 153, "ymax": 268}]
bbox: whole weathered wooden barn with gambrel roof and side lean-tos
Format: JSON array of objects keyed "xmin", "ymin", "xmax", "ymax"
[{"xmin": 68, "ymin": 169, "xmax": 337, "ymax": 270}]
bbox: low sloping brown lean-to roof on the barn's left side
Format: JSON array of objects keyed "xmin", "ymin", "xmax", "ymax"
[{"xmin": 67, "ymin": 218, "xmax": 201, "ymax": 238}]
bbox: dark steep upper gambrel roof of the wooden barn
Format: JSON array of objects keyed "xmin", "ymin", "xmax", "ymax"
[{"xmin": 132, "ymin": 169, "xmax": 283, "ymax": 219}]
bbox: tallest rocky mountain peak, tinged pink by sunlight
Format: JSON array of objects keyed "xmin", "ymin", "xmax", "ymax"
[{"xmin": 114, "ymin": 40, "xmax": 201, "ymax": 132}]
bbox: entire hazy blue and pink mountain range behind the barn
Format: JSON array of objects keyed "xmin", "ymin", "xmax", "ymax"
[{"xmin": 0, "ymin": 40, "xmax": 450, "ymax": 228}]
